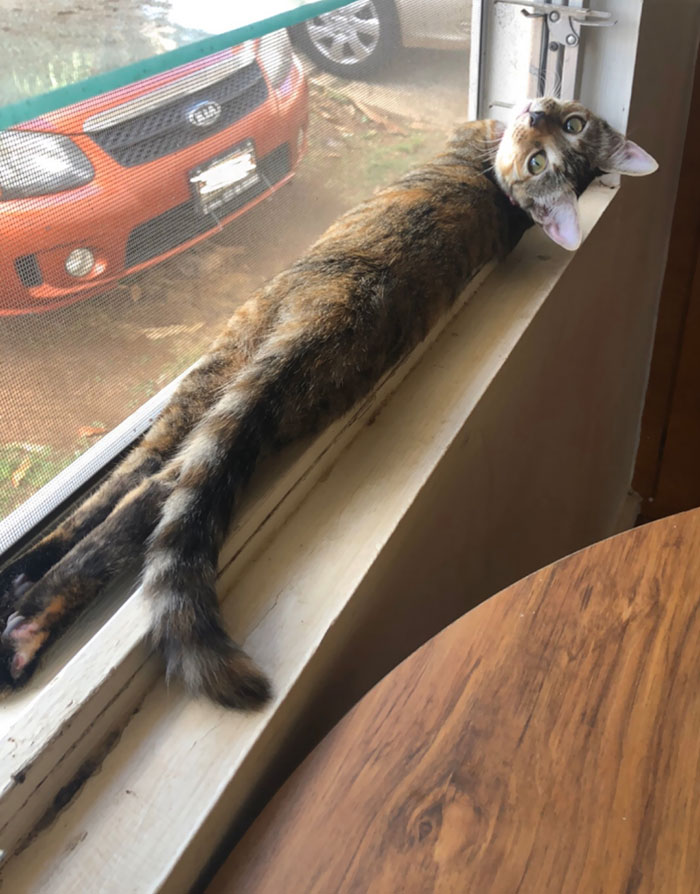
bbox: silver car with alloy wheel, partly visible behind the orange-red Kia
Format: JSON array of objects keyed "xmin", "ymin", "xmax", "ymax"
[{"xmin": 290, "ymin": 0, "xmax": 471, "ymax": 77}]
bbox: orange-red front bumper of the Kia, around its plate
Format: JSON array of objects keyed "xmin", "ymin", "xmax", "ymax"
[{"xmin": 0, "ymin": 56, "xmax": 308, "ymax": 316}]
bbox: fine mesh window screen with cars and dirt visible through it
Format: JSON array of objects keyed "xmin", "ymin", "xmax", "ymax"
[{"xmin": 0, "ymin": 0, "xmax": 471, "ymax": 551}]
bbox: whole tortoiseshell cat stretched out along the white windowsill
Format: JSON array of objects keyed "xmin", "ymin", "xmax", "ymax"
[{"xmin": 0, "ymin": 99, "xmax": 656, "ymax": 707}]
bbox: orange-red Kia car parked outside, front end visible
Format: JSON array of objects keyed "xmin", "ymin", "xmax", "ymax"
[{"xmin": 0, "ymin": 32, "xmax": 308, "ymax": 316}]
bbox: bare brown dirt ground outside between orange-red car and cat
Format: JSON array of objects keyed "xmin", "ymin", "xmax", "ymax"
[{"xmin": 0, "ymin": 50, "xmax": 467, "ymax": 518}]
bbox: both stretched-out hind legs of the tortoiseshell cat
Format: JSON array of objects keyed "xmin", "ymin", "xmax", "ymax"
[{"xmin": 0, "ymin": 281, "xmax": 279, "ymax": 685}]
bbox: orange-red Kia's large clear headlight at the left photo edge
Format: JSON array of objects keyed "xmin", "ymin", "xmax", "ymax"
[{"xmin": 0, "ymin": 130, "xmax": 95, "ymax": 199}]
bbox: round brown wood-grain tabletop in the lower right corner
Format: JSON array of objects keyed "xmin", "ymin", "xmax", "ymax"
[{"xmin": 209, "ymin": 510, "xmax": 700, "ymax": 894}]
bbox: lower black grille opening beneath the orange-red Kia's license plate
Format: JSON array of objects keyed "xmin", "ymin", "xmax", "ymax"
[{"xmin": 126, "ymin": 143, "xmax": 291, "ymax": 267}]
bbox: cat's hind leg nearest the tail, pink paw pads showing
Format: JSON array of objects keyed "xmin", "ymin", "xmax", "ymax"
[{"xmin": 0, "ymin": 462, "xmax": 179, "ymax": 689}]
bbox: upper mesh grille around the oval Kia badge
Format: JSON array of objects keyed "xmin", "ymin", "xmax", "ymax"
[{"xmin": 90, "ymin": 62, "xmax": 268, "ymax": 168}]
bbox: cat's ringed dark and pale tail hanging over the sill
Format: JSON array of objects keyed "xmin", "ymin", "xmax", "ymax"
[{"xmin": 143, "ymin": 327, "xmax": 318, "ymax": 707}]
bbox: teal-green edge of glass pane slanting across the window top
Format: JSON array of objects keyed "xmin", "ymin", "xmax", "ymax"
[{"xmin": 0, "ymin": 0, "xmax": 348, "ymax": 130}]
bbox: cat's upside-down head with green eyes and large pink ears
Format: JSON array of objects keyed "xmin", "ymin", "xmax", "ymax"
[{"xmin": 494, "ymin": 97, "xmax": 658, "ymax": 251}]
